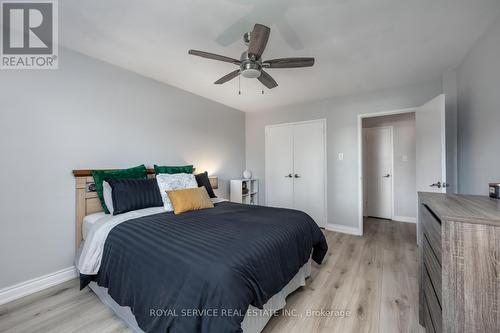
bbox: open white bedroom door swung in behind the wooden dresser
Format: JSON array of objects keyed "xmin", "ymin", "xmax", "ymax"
[{"xmin": 415, "ymin": 94, "xmax": 448, "ymax": 193}]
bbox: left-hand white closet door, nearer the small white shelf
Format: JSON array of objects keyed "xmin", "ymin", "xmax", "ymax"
[{"xmin": 266, "ymin": 126, "xmax": 293, "ymax": 208}]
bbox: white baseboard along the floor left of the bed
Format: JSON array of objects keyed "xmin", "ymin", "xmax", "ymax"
[{"xmin": 0, "ymin": 266, "xmax": 78, "ymax": 305}]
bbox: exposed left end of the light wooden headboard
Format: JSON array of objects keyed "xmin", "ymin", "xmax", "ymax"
[{"xmin": 73, "ymin": 169, "xmax": 155, "ymax": 249}]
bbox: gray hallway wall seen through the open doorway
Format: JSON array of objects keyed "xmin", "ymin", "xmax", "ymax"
[{"xmin": 363, "ymin": 112, "xmax": 417, "ymax": 218}]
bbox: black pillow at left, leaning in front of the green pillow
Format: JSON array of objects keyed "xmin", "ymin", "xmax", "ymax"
[{"xmin": 106, "ymin": 178, "xmax": 163, "ymax": 215}]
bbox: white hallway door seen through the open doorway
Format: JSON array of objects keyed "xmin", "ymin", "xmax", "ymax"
[{"xmin": 363, "ymin": 127, "xmax": 393, "ymax": 219}]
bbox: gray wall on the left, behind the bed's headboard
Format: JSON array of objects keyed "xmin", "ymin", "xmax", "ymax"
[{"xmin": 0, "ymin": 50, "xmax": 245, "ymax": 289}]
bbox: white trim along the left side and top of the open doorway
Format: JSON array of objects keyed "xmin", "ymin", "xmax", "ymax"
[{"xmin": 358, "ymin": 107, "xmax": 417, "ymax": 236}]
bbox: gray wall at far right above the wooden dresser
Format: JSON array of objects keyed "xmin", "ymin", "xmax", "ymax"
[{"xmin": 458, "ymin": 14, "xmax": 500, "ymax": 195}]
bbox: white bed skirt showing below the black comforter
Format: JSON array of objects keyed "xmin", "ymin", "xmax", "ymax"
[{"xmin": 89, "ymin": 260, "xmax": 311, "ymax": 333}]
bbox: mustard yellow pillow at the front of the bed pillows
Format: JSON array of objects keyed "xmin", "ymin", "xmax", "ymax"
[{"xmin": 167, "ymin": 186, "xmax": 214, "ymax": 215}]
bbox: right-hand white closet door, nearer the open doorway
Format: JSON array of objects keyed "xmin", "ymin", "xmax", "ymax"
[{"xmin": 293, "ymin": 121, "xmax": 326, "ymax": 227}]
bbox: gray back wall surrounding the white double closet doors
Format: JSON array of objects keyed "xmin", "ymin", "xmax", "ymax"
[{"xmin": 246, "ymin": 80, "xmax": 442, "ymax": 228}]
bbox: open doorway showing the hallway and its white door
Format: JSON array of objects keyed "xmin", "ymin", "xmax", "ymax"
[{"xmin": 362, "ymin": 112, "xmax": 417, "ymax": 223}]
